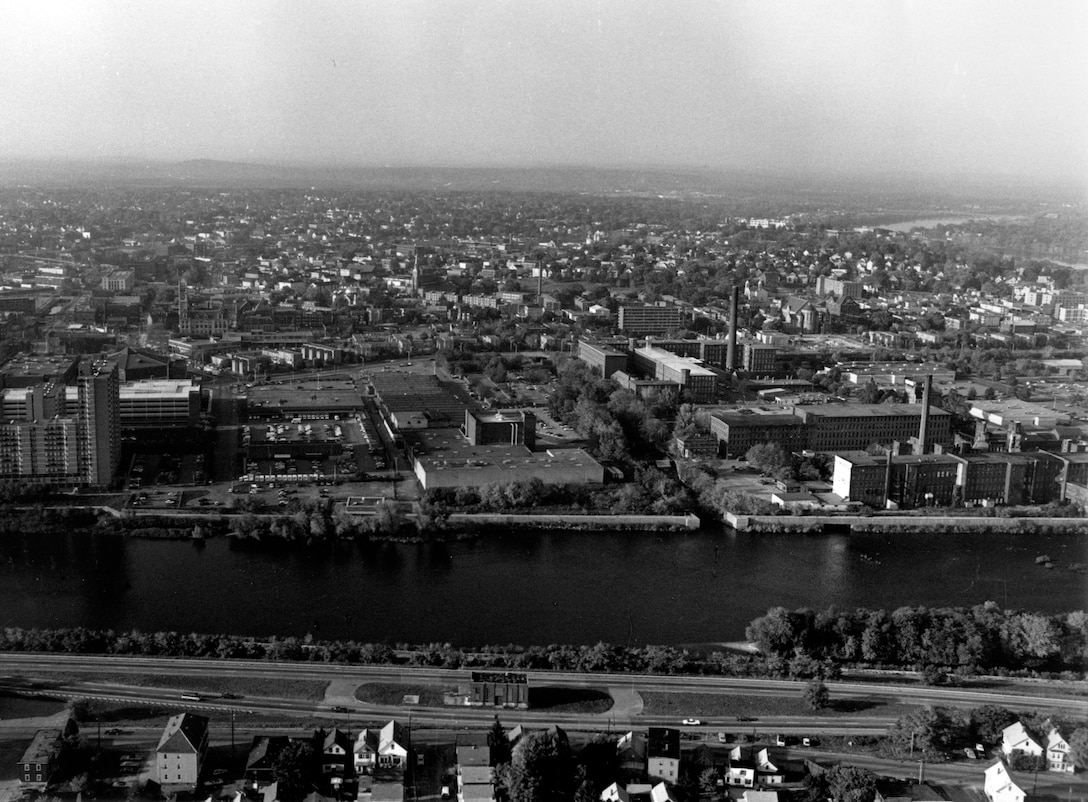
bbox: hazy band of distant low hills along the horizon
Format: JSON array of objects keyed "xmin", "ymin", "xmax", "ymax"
[{"xmin": 0, "ymin": 159, "xmax": 1086, "ymax": 209}]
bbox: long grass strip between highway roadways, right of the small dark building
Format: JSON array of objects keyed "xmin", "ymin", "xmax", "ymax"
[{"xmin": 639, "ymin": 691, "xmax": 915, "ymax": 724}]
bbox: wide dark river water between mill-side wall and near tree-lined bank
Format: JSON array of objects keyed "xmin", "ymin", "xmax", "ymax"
[{"xmin": 0, "ymin": 530, "xmax": 1088, "ymax": 645}]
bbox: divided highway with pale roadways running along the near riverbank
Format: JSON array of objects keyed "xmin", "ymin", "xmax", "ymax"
[{"xmin": 0, "ymin": 653, "xmax": 1088, "ymax": 735}]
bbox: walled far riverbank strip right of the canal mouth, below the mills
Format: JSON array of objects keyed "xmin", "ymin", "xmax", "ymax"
[{"xmin": 725, "ymin": 513, "xmax": 1088, "ymax": 534}]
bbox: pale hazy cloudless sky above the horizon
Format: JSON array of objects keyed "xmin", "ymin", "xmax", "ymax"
[{"xmin": 0, "ymin": 0, "xmax": 1088, "ymax": 181}]
